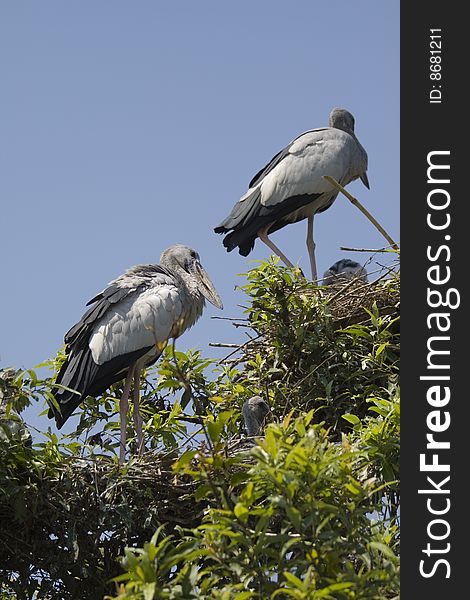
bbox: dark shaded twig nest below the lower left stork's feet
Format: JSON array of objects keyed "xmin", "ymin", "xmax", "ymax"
[{"xmin": 0, "ymin": 448, "xmax": 201, "ymax": 598}]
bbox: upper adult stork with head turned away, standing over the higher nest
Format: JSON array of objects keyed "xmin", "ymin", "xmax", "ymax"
[{"xmin": 214, "ymin": 108, "xmax": 369, "ymax": 280}]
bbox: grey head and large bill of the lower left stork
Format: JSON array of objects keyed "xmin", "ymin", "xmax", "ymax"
[{"xmin": 160, "ymin": 244, "xmax": 223, "ymax": 308}]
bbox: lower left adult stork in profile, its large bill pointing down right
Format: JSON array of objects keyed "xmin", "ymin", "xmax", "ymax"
[{"xmin": 48, "ymin": 244, "xmax": 222, "ymax": 464}]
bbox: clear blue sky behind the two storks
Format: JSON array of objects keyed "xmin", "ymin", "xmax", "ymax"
[{"xmin": 0, "ymin": 0, "xmax": 399, "ymax": 432}]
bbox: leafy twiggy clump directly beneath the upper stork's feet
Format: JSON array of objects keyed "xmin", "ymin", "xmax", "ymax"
[{"xmin": 237, "ymin": 263, "xmax": 399, "ymax": 435}]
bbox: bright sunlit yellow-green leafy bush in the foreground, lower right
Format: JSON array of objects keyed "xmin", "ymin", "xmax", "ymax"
[{"xmin": 108, "ymin": 412, "xmax": 398, "ymax": 599}]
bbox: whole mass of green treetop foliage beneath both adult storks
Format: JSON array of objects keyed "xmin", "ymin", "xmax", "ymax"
[{"xmin": 0, "ymin": 263, "xmax": 400, "ymax": 600}]
